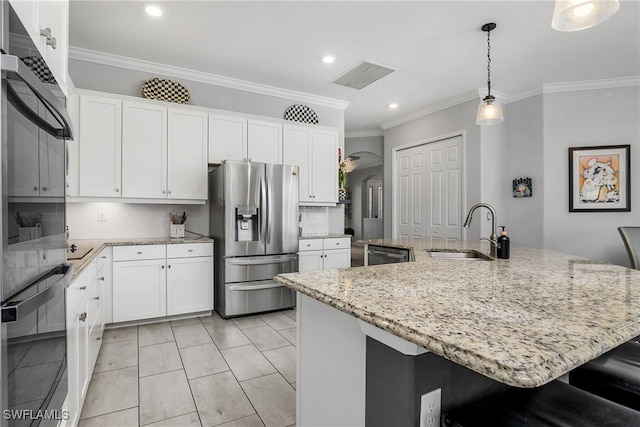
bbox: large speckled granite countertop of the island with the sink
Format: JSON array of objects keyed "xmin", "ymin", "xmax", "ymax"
[{"xmin": 276, "ymin": 238, "xmax": 640, "ymax": 387}]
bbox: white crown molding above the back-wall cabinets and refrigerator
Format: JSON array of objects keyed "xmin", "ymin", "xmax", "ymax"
[{"xmin": 69, "ymin": 46, "xmax": 349, "ymax": 110}]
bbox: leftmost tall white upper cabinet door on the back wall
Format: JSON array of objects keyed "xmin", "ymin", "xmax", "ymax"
[{"xmin": 78, "ymin": 95, "xmax": 122, "ymax": 197}]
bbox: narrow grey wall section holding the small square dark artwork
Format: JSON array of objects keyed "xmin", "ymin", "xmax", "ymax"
[{"xmin": 503, "ymin": 95, "xmax": 546, "ymax": 248}]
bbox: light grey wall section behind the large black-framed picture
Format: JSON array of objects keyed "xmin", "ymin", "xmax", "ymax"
[{"xmin": 543, "ymin": 86, "xmax": 640, "ymax": 266}]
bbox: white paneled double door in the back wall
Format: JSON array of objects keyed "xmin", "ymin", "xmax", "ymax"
[{"xmin": 394, "ymin": 136, "xmax": 463, "ymax": 246}]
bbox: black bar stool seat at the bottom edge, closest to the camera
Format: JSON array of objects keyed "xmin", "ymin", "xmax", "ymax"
[{"xmin": 442, "ymin": 381, "xmax": 640, "ymax": 427}]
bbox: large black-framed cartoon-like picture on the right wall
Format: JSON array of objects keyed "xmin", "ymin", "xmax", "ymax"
[{"xmin": 569, "ymin": 145, "xmax": 631, "ymax": 212}]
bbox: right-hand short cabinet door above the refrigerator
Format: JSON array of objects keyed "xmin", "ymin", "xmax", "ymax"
[{"xmin": 247, "ymin": 119, "xmax": 282, "ymax": 164}]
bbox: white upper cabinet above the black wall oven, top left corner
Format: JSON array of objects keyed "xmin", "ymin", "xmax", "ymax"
[{"xmin": 10, "ymin": 0, "xmax": 69, "ymax": 92}]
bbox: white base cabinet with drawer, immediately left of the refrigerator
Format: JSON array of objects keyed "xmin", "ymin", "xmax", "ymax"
[{"xmin": 167, "ymin": 243, "xmax": 213, "ymax": 316}]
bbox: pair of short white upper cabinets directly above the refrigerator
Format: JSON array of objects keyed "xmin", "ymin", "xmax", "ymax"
[{"xmin": 209, "ymin": 114, "xmax": 282, "ymax": 164}]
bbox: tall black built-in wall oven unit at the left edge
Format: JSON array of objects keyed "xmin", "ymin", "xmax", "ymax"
[{"xmin": 0, "ymin": 0, "xmax": 72, "ymax": 426}]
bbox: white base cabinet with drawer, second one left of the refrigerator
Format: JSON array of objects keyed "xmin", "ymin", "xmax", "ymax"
[{"xmin": 113, "ymin": 245, "xmax": 167, "ymax": 322}]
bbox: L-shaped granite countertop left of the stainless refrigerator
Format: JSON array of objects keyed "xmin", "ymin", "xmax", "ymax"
[{"xmin": 67, "ymin": 237, "xmax": 213, "ymax": 280}]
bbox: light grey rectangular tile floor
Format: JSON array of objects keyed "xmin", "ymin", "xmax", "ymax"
[{"xmin": 79, "ymin": 310, "xmax": 296, "ymax": 427}]
